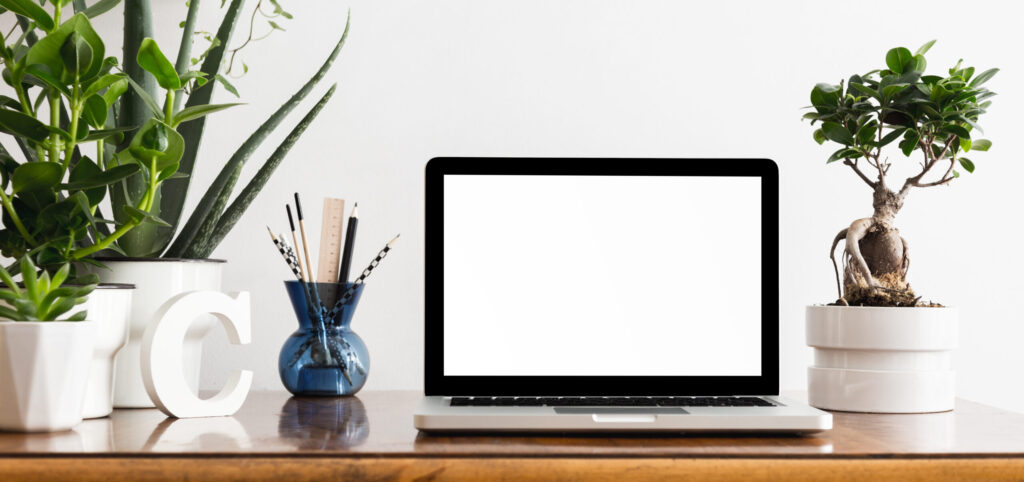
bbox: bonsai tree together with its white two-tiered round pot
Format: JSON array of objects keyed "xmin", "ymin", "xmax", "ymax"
[{"xmin": 804, "ymin": 41, "xmax": 997, "ymax": 412}]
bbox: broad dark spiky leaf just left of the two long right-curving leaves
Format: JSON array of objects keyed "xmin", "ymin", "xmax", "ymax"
[{"xmin": 159, "ymin": 0, "xmax": 244, "ymax": 256}]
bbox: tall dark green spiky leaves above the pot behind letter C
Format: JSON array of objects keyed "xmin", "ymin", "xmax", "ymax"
[{"xmin": 110, "ymin": 0, "xmax": 349, "ymax": 258}]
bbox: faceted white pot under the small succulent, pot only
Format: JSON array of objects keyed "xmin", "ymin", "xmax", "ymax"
[{"xmin": 0, "ymin": 321, "xmax": 96, "ymax": 432}]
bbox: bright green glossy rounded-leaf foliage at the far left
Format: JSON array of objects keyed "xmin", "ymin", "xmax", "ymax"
[{"xmin": 0, "ymin": 0, "xmax": 235, "ymax": 272}]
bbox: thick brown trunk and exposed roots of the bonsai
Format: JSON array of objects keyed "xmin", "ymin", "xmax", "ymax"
[{"xmin": 829, "ymin": 182, "xmax": 920, "ymax": 306}]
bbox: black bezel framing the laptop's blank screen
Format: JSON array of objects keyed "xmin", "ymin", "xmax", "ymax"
[{"xmin": 424, "ymin": 158, "xmax": 779, "ymax": 396}]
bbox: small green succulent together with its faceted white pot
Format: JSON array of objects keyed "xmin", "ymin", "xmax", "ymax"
[{"xmin": 0, "ymin": 256, "xmax": 96, "ymax": 432}]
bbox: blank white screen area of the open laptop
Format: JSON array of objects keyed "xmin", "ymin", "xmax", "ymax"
[{"xmin": 443, "ymin": 175, "xmax": 761, "ymax": 376}]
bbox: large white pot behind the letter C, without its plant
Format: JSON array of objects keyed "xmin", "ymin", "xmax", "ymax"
[{"xmin": 94, "ymin": 258, "xmax": 224, "ymax": 408}]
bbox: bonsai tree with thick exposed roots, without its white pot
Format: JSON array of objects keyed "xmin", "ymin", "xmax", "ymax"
[{"xmin": 804, "ymin": 40, "xmax": 998, "ymax": 306}]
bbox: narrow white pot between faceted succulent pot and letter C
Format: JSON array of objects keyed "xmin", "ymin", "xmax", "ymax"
[{"xmin": 76, "ymin": 283, "xmax": 135, "ymax": 419}]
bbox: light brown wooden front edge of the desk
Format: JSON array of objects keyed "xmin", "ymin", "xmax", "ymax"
[{"xmin": 0, "ymin": 454, "xmax": 1024, "ymax": 482}]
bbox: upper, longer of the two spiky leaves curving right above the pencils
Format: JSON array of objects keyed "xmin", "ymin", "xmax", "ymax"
[{"xmin": 167, "ymin": 13, "xmax": 351, "ymax": 257}]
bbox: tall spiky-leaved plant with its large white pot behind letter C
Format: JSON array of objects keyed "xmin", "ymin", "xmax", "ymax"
[{"xmin": 74, "ymin": 0, "xmax": 349, "ymax": 407}]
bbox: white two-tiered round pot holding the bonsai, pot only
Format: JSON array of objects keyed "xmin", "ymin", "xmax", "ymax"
[{"xmin": 807, "ymin": 306, "xmax": 957, "ymax": 413}]
